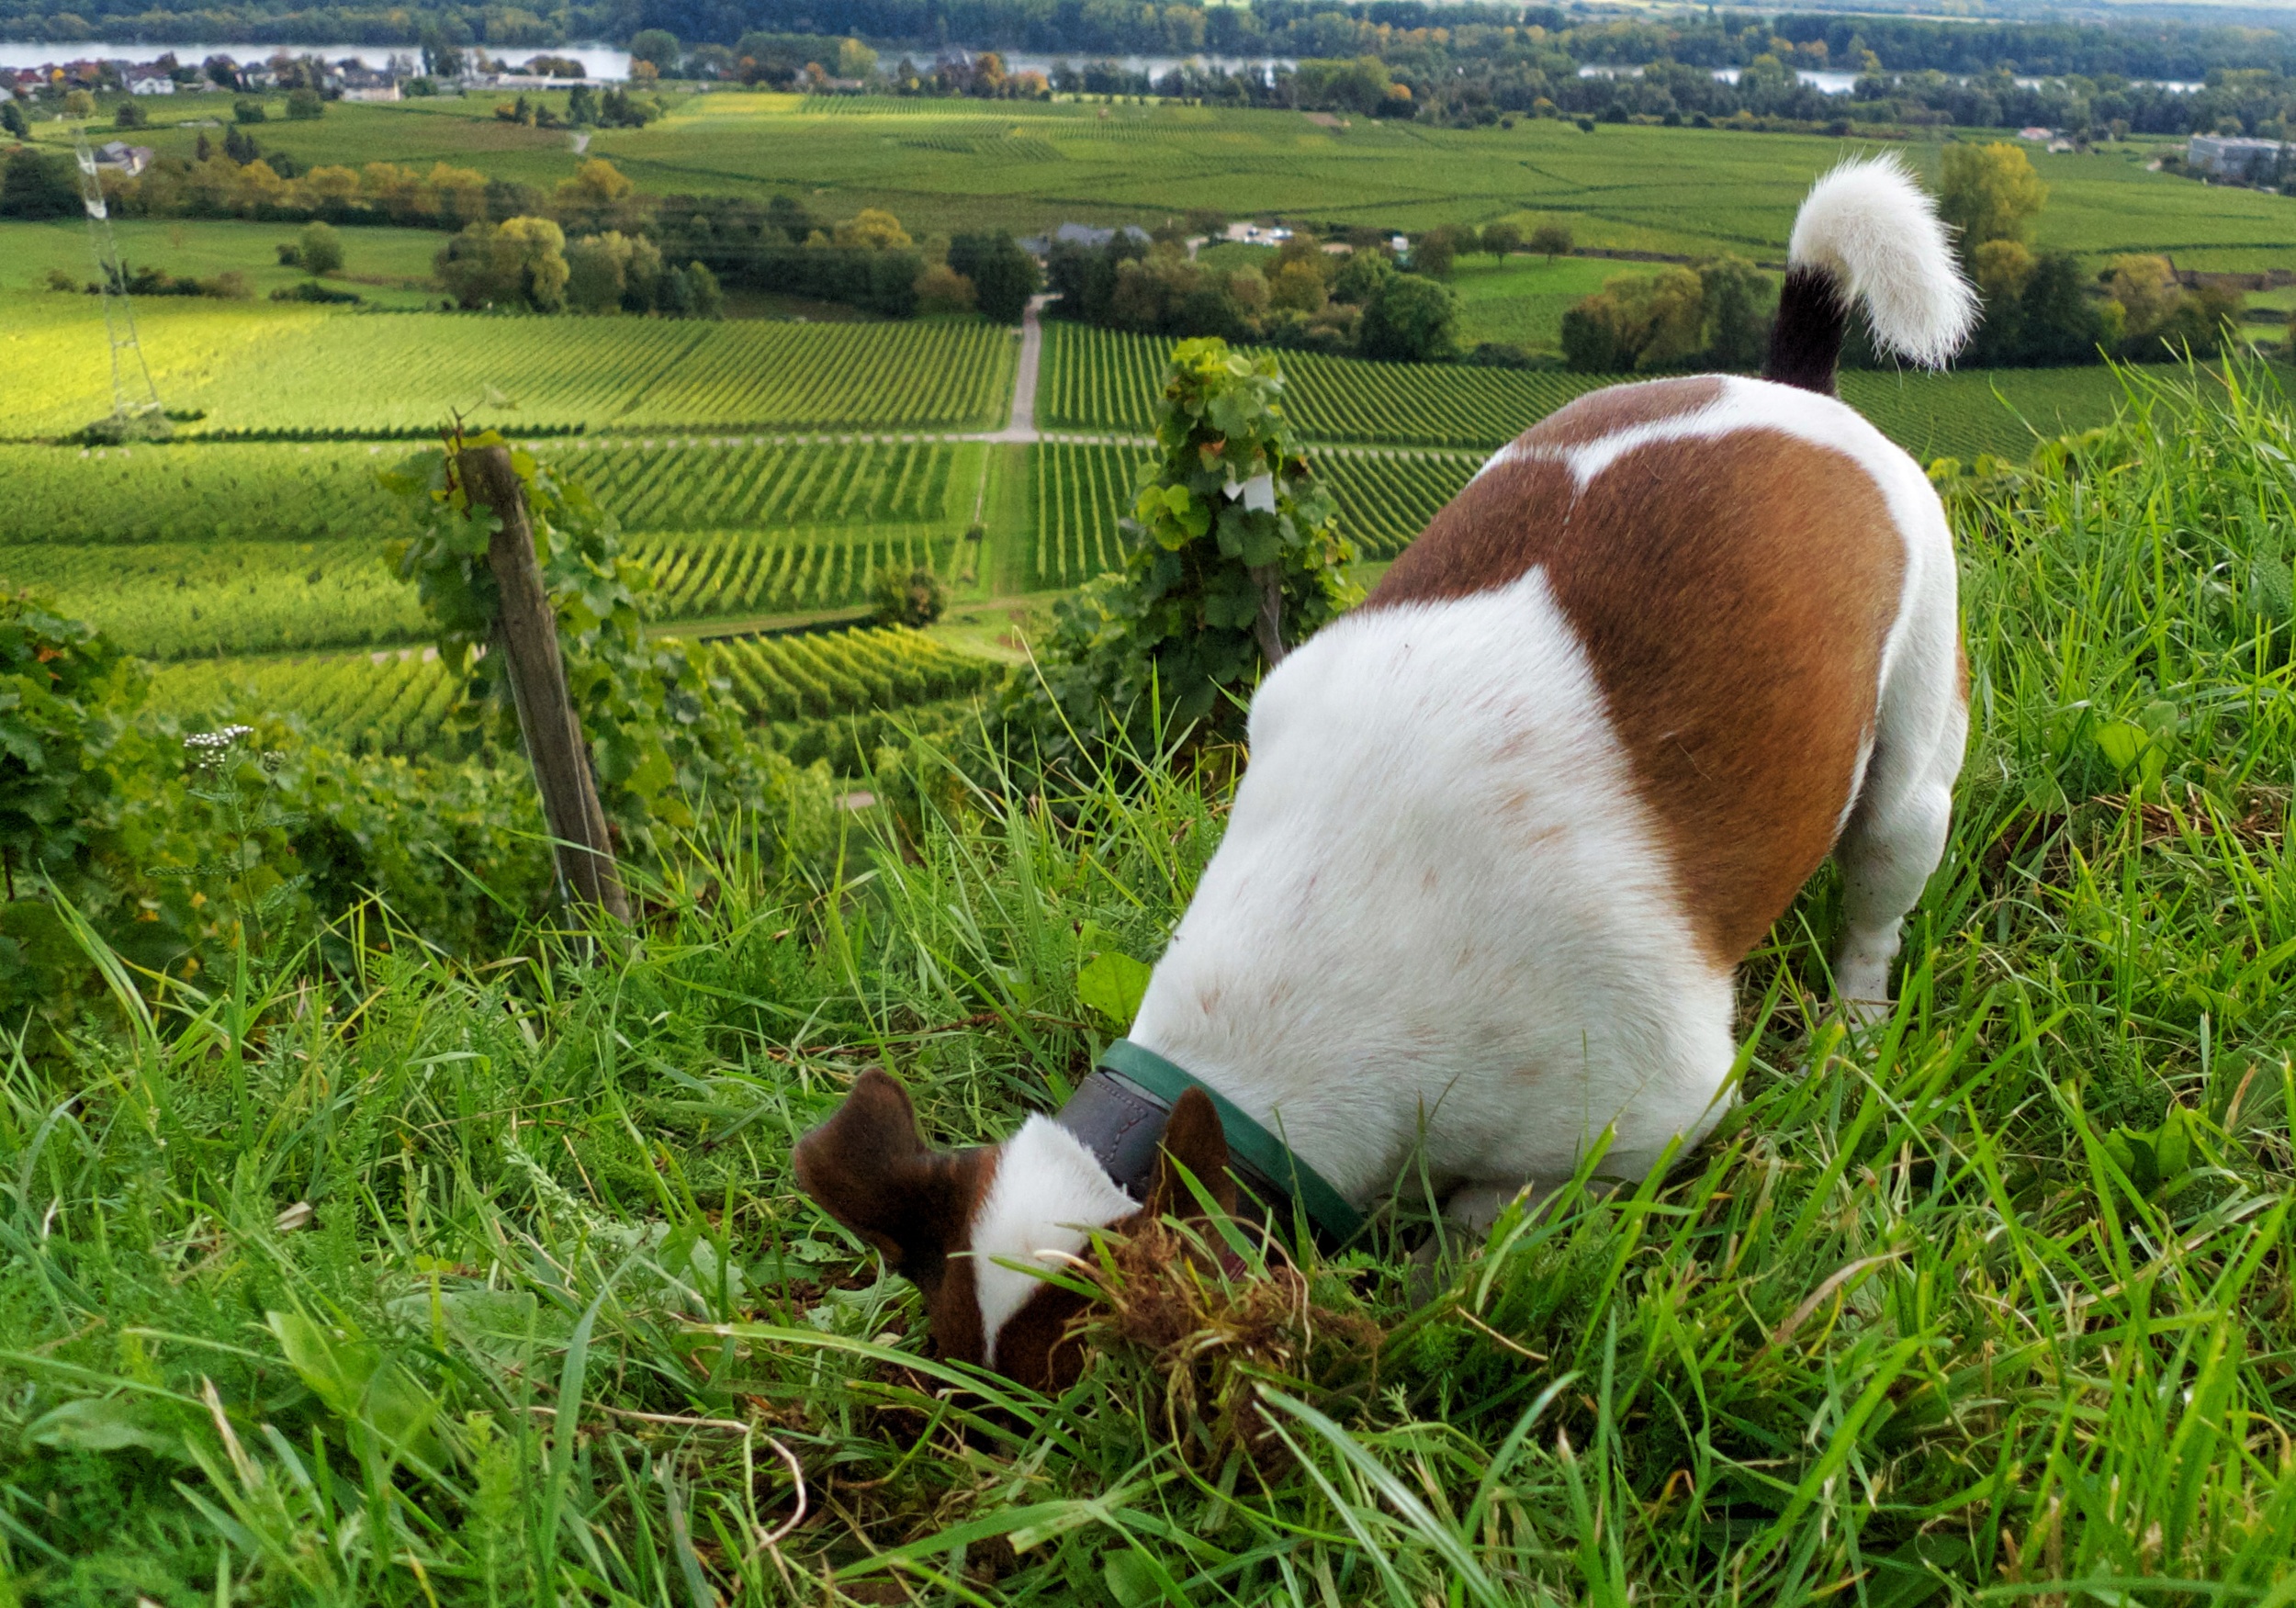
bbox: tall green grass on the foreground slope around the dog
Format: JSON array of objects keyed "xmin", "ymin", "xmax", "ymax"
[{"xmin": 0, "ymin": 358, "xmax": 2296, "ymax": 1608}]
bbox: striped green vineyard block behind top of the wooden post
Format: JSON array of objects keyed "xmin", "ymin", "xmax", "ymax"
[{"xmin": 0, "ymin": 436, "xmax": 987, "ymax": 659}]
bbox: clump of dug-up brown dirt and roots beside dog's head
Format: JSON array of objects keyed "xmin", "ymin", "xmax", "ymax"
[{"xmin": 1077, "ymin": 1220, "xmax": 1387, "ymax": 1472}]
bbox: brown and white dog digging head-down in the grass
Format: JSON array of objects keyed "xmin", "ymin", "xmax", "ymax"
[{"xmin": 797, "ymin": 161, "xmax": 1975, "ymax": 1383}]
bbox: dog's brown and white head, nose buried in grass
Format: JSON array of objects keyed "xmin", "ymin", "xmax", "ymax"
[{"xmin": 794, "ymin": 1068, "xmax": 1235, "ymax": 1389}]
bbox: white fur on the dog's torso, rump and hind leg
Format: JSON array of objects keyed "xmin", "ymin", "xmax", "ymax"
[{"xmin": 1132, "ymin": 379, "xmax": 1965, "ymax": 1204}]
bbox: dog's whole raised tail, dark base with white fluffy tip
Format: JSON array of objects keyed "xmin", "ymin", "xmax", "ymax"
[{"xmin": 1761, "ymin": 156, "xmax": 1977, "ymax": 395}]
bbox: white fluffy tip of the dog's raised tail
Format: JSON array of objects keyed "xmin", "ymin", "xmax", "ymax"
[{"xmin": 1786, "ymin": 156, "xmax": 1977, "ymax": 367}]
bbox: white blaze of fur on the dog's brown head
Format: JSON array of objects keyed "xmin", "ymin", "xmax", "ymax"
[{"xmin": 969, "ymin": 1117, "xmax": 1139, "ymax": 1365}]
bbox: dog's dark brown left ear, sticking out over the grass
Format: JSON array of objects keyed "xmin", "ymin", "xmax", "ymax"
[{"xmin": 793, "ymin": 1066, "xmax": 981, "ymax": 1288}]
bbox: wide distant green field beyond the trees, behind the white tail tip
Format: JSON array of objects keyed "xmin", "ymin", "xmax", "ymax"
[{"xmin": 565, "ymin": 95, "xmax": 2296, "ymax": 269}]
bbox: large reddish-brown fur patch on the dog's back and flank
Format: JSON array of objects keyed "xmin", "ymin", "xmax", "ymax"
[{"xmin": 1367, "ymin": 418, "xmax": 1906, "ymax": 965}]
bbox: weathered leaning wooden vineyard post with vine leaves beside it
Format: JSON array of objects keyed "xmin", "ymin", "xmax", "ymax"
[{"xmin": 457, "ymin": 445, "xmax": 629, "ymax": 921}]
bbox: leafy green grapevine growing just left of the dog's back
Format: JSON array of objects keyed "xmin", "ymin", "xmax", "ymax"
[{"xmin": 1006, "ymin": 337, "xmax": 1359, "ymax": 760}]
